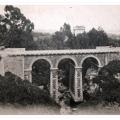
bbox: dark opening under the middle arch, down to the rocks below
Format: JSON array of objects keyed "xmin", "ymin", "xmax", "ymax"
[{"xmin": 58, "ymin": 58, "xmax": 75, "ymax": 105}]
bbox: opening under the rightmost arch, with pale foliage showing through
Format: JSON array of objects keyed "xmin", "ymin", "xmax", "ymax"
[{"xmin": 82, "ymin": 57, "xmax": 99, "ymax": 100}]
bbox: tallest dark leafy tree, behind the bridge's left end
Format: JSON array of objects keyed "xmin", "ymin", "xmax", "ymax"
[{"xmin": 0, "ymin": 5, "xmax": 36, "ymax": 49}]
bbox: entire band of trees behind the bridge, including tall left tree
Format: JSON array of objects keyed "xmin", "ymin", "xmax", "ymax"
[{"xmin": 0, "ymin": 5, "xmax": 120, "ymax": 50}]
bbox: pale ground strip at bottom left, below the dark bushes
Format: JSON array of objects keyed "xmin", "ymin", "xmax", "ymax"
[{"xmin": 0, "ymin": 104, "xmax": 59, "ymax": 115}]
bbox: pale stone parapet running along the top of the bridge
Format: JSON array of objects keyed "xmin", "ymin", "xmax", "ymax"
[{"xmin": 0, "ymin": 47, "xmax": 120, "ymax": 56}]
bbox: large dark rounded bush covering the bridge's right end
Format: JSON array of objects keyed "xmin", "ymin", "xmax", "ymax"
[{"xmin": 94, "ymin": 60, "xmax": 120, "ymax": 103}]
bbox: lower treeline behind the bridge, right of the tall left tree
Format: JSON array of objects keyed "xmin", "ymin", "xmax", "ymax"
[{"xmin": 35, "ymin": 23, "xmax": 120, "ymax": 49}]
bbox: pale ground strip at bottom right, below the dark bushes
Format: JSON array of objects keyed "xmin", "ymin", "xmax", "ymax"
[{"xmin": 73, "ymin": 103, "xmax": 120, "ymax": 115}]
